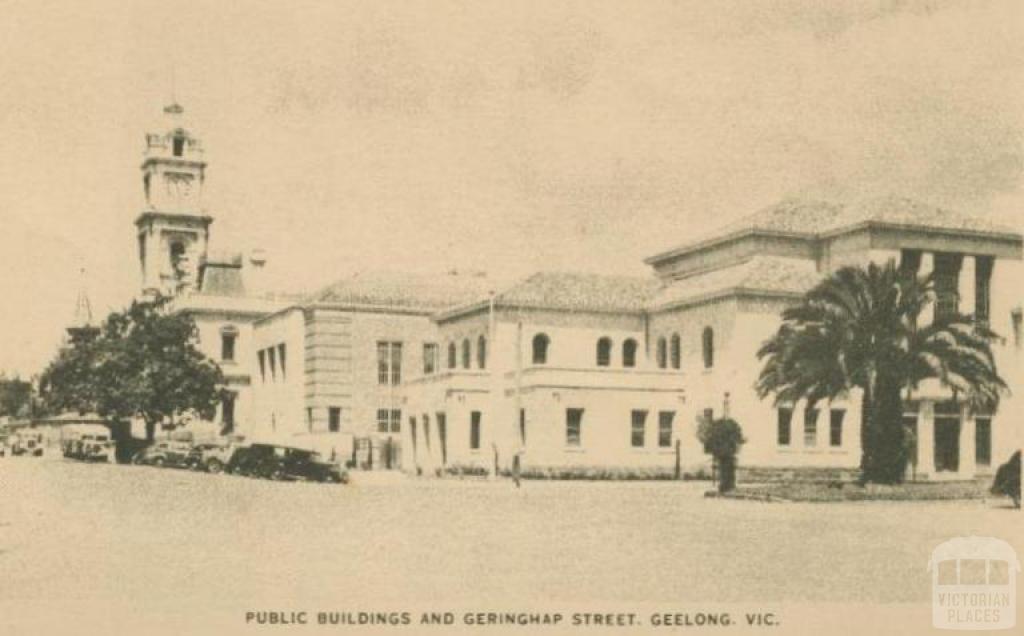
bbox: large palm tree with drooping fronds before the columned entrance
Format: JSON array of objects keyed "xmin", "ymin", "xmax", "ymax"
[{"xmin": 757, "ymin": 261, "xmax": 1006, "ymax": 483}]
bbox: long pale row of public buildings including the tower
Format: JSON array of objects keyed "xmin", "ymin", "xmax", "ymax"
[{"xmin": 135, "ymin": 105, "xmax": 1022, "ymax": 478}]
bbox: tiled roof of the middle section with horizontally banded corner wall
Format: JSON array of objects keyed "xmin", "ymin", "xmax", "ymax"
[{"xmin": 307, "ymin": 271, "xmax": 493, "ymax": 312}]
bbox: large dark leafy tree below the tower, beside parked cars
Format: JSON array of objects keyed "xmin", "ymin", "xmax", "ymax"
[{"xmin": 42, "ymin": 298, "xmax": 223, "ymax": 440}]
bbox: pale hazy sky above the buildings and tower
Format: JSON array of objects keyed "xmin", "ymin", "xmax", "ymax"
[{"xmin": 0, "ymin": 0, "xmax": 1024, "ymax": 377}]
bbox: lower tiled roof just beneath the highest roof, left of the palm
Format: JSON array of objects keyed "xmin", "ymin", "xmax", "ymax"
[{"xmin": 648, "ymin": 256, "xmax": 821, "ymax": 309}]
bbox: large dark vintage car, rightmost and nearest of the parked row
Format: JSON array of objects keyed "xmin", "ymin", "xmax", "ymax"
[{"xmin": 227, "ymin": 443, "xmax": 348, "ymax": 483}]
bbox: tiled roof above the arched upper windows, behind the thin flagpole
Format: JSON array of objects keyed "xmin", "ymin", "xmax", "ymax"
[{"xmin": 496, "ymin": 271, "xmax": 660, "ymax": 312}]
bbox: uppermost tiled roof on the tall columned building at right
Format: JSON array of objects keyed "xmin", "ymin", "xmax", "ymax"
[{"xmin": 647, "ymin": 197, "xmax": 1018, "ymax": 262}]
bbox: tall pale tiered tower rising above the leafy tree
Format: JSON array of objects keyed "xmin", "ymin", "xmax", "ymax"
[{"xmin": 135, "ymin": 103, "xmax": 213, "ymax": 296}]
